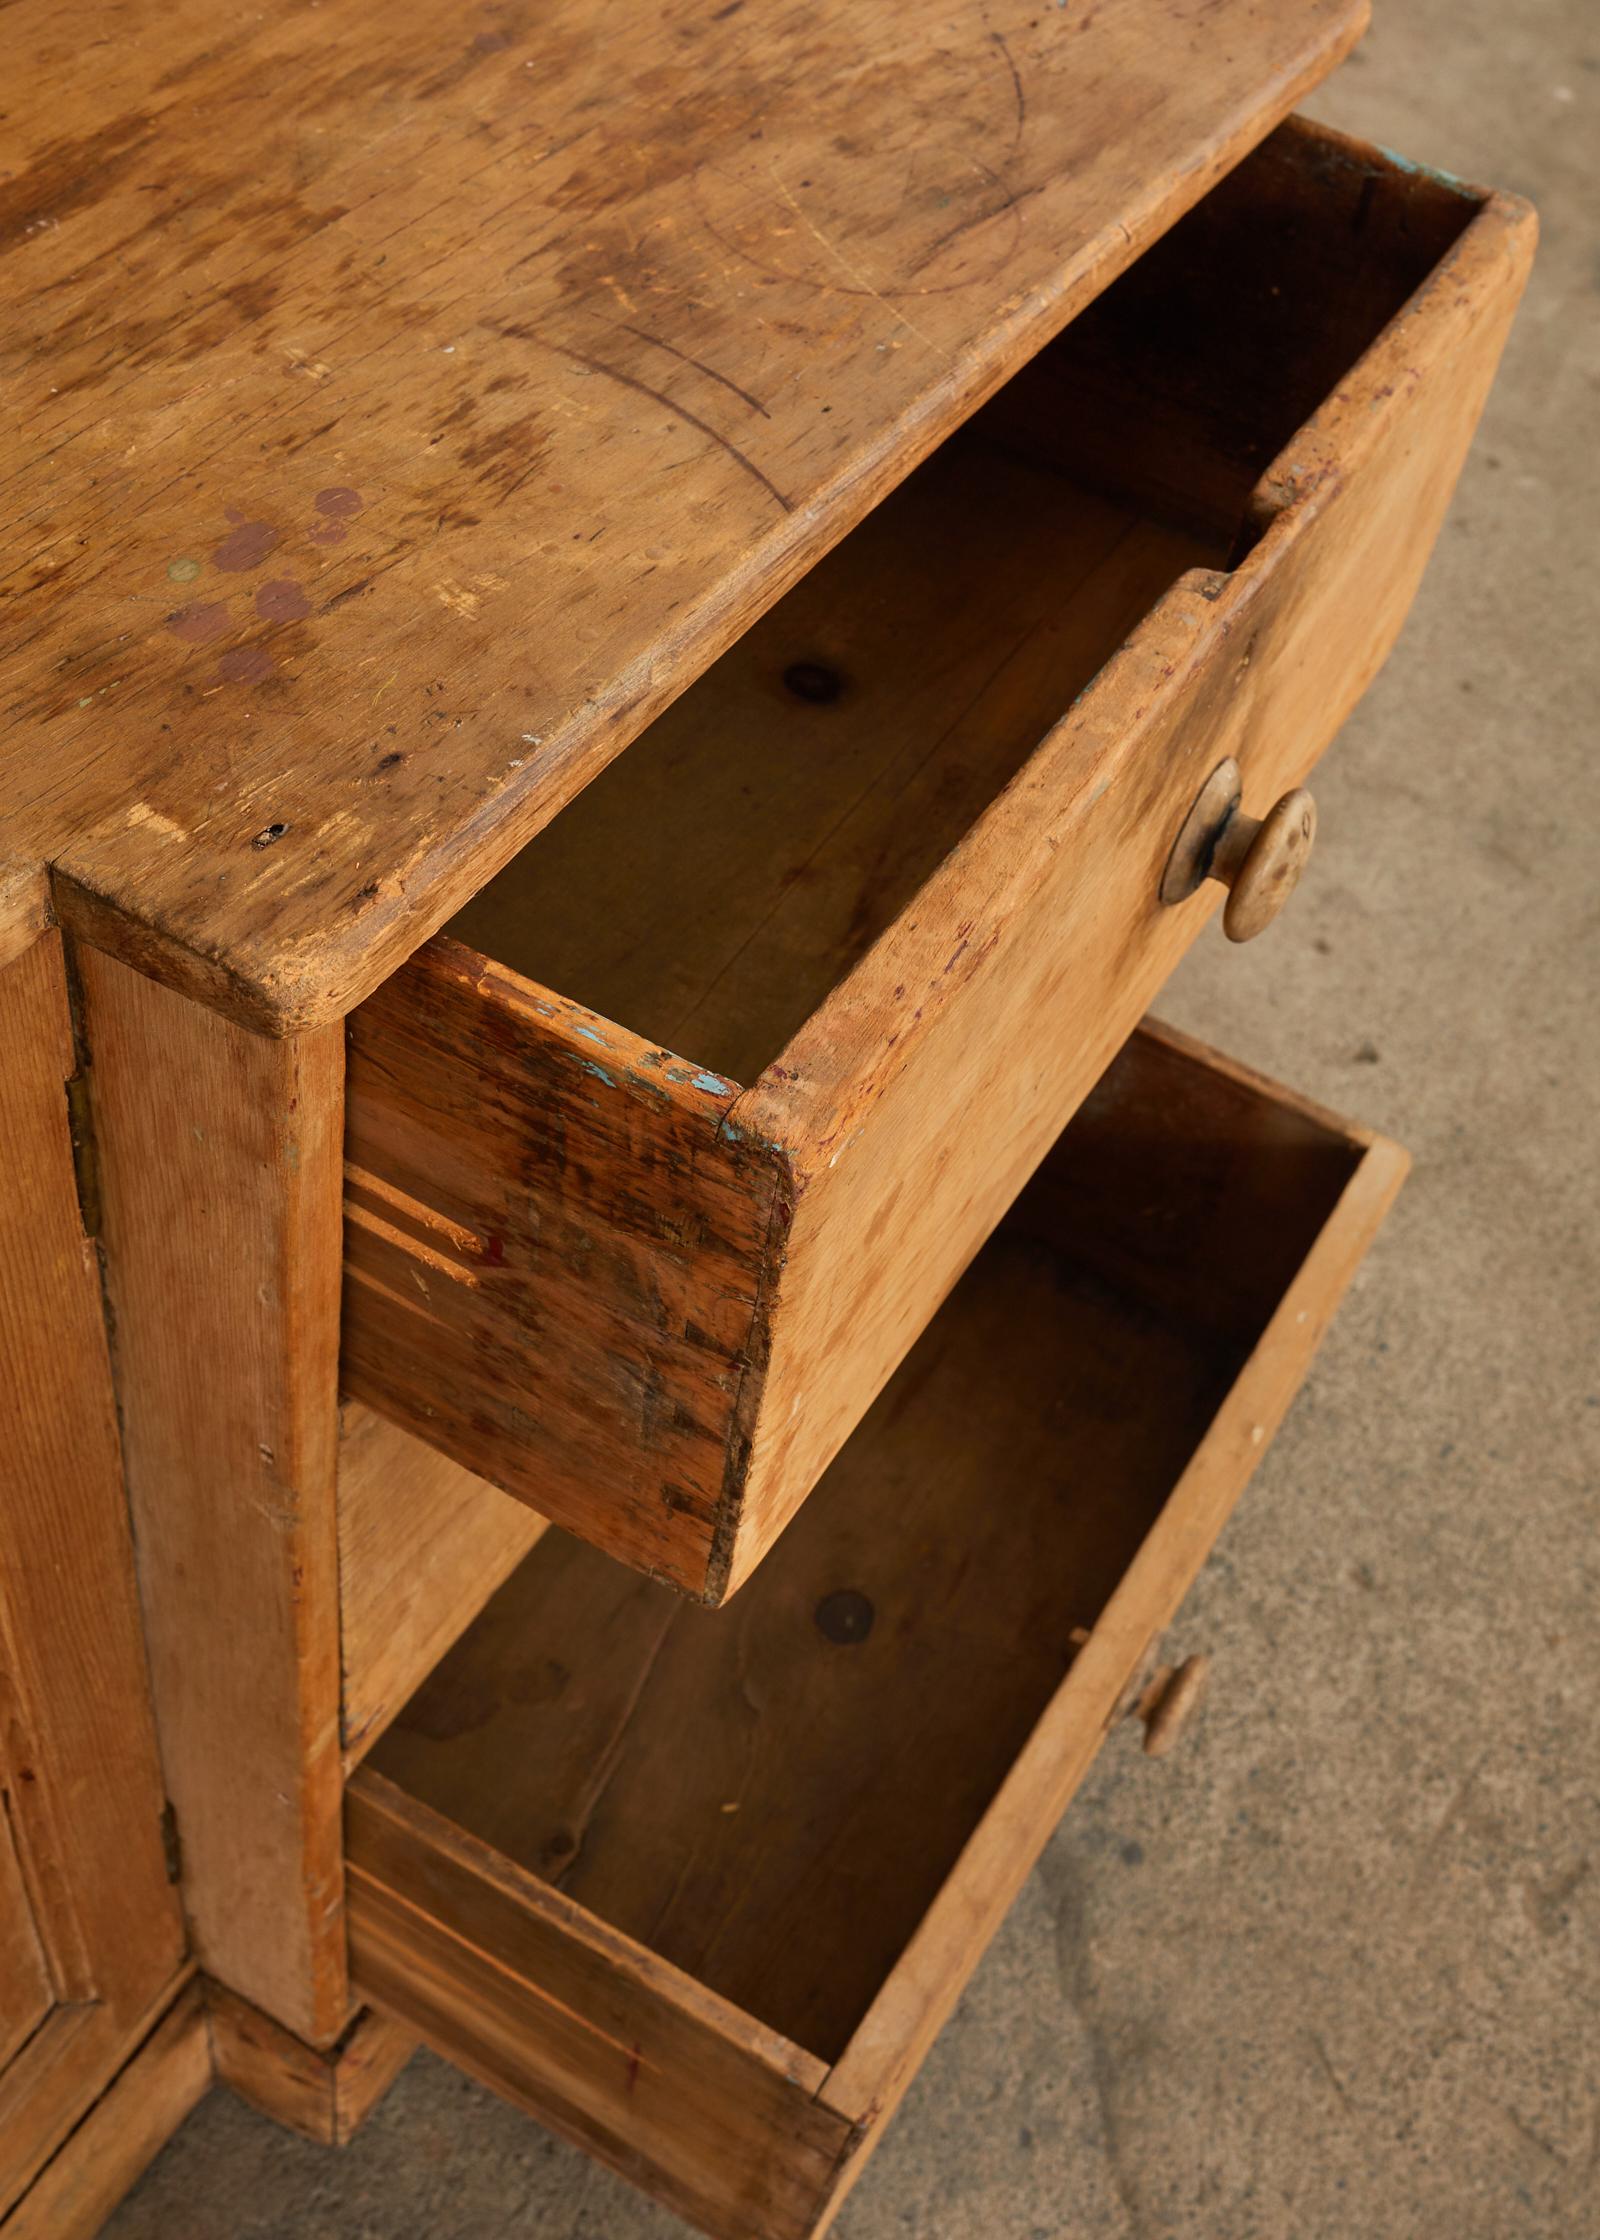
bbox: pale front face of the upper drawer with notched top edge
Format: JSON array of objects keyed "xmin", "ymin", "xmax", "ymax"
[{"xmin": 728, "ymin": 183, "xmax": 1535, "ymax": 1586}]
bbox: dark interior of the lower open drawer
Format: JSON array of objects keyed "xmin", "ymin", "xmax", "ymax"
[{"xmin": 370, "ymin": 1033, "xmax": 1360, "ymax": 2061}]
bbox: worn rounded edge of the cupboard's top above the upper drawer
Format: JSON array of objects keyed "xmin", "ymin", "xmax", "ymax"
[{"xmin": 52, "ymin": 24, "xmax": 1371, "ymax": 1035}]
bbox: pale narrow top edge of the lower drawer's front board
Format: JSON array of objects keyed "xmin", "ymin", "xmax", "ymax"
[{"xmin": 820, "ymin": 1084, "xmax": 1410, "ymax": 2132}]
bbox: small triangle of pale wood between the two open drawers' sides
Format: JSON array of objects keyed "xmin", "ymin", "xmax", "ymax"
[{"xmin": 338, "ymin": 1400, "xmax": 545, "ymax": 1770}]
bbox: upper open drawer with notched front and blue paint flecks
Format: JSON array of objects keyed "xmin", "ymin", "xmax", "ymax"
[{"xmin": 343, "ymin": 123, "xmax": 1533, "ymax": 1602}]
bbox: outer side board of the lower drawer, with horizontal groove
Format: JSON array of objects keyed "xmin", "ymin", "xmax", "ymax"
[{"xmin": 350, "ymin": 1767, "xmax": 852, "ymax": 2240}]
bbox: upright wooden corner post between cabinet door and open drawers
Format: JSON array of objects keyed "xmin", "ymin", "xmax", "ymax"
[{"xmin": 81, "ymin": 952, "xmax": 347, "ymax": 2043}]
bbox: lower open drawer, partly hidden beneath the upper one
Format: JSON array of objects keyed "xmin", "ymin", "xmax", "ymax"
[{"xmin": 347, "ymin": 1028, "xmax": 1405, "ymax": 2240}]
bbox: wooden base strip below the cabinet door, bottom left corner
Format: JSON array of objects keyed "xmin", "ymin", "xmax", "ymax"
[{"xmin": 0, "ymin": 1969, "xmax": 211, "ymax": 2240}]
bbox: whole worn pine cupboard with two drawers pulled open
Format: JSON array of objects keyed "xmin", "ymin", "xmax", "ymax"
[{"xmin": 0, "ymin": 0, "xmax": 1535, "ymax": 2240}]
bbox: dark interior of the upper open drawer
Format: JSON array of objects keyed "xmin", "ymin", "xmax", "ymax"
[{"xmin": 450, "ymin": 123, "xmax": 1477, "ymax": 1082}]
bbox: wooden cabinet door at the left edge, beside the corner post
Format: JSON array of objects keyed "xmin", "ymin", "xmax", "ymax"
[{"xmin": 0, "ymin": 932, "xmax": 184, "ymax": 2215}]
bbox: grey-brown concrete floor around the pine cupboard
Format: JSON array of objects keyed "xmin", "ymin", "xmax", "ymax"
[{"xmin": 108, "ymin": 0, "xmax": 1600, "ymax": 2240}]
